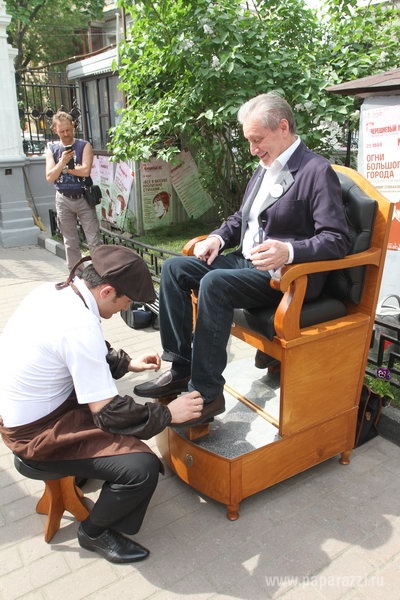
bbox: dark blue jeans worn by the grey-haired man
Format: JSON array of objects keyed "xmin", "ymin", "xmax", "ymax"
[{"xmin": 160, "ymin": 252, "xmax": 282, "ymax": 402}]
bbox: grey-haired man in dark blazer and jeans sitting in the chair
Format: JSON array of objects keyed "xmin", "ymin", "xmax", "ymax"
[{"xmin": 134, "ymin": 92, "xmax": 350, "ymax": 425}]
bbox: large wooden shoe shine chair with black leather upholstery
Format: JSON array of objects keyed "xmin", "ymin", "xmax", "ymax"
[{"xmin": 158, "ymin": 165, "xmax": 393, "ymax": 520}]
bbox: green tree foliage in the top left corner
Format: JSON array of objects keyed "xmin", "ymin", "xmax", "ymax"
[{"xmin": 5, "ymin": 0, "xmax": 104, "ymax": 71}]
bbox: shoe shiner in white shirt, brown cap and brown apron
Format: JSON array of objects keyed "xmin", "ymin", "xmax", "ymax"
[{"xmin": 0, "ymin": 246, "xmax": 203, "ymax": 563}]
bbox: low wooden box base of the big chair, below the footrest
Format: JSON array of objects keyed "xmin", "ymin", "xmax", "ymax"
[{"xmin": 157, "ymin": 411, "xmax": 356, "ymax": 521}]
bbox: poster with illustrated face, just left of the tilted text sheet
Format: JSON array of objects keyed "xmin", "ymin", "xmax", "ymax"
[{"xmin": 140, "ymin": 158, "xmax": 172, "ymax": 228}]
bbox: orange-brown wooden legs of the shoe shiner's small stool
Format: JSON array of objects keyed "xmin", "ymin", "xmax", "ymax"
[{"xmin": 36, "ymin": 477, "xmax": 89, "ymax": 542}]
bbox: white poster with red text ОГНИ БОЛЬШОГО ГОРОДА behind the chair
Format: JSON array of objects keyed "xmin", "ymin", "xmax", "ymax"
[{"xmin": 358, "ymin": 104, "xmax": 400, "ymax": 250}]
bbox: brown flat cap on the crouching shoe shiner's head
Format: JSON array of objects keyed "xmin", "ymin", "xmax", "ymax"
[{"xmin": 92, "ymin": 245, "xmax": 156, "ymax": 302}]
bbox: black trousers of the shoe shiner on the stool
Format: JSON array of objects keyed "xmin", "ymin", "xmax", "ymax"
[{"xmin": 26, "ymin": 452, "xmax": 160, "ymax": 535}]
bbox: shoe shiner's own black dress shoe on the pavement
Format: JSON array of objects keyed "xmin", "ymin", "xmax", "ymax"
[{"xmin": 78, "ymin": 525, "xmax": 150, "ymax": 563}]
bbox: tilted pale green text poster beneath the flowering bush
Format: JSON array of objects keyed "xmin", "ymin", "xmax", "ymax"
[{"xmin": 171, "ymin": 150, "xmax": 213, "ymax": 219}]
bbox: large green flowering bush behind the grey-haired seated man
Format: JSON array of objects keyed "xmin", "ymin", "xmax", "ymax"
[{"xmin": 110, "ymin": 0, "xmax": 398, "ymax": 216}]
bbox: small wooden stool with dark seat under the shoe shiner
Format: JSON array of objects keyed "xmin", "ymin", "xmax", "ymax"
[{"xmin": 14, "ymin": 454, "xmax": 89, "ymax": 542}]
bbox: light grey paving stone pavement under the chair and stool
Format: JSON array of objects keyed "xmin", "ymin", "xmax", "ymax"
[{"xmin": 0, "ymin": 246, "xmax": 400, "ymax": 600}]
